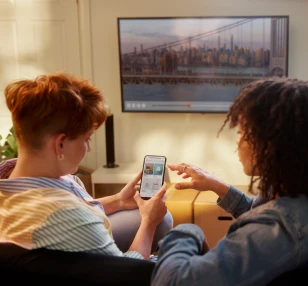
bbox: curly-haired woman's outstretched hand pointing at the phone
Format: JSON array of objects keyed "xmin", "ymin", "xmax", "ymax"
[{"xmin": 167, "ymin": 163, "xmax": 230, "ymax": 198}]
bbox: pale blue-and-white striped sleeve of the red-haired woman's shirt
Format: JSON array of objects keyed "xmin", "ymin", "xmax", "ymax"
[{"xmin": 32, "ymin": 208, "xmax": 144, "ymax": 259}]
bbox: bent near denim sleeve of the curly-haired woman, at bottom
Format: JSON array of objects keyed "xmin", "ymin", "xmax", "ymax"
[{"xmin": 151, "ymin": 211, "xmax": 299, "ymax": 286}]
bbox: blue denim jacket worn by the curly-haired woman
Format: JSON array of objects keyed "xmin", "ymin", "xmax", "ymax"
[{"xmin": 151, "ymin": 186, "xmax": 308, "ymax": 286}]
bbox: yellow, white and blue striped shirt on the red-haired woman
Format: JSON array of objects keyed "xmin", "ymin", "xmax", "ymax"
[{"xmin": 0, "ymin": 159, "xmax": 143, "ymax": 259}]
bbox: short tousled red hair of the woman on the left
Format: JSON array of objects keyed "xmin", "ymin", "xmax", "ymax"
[{"xmin": 4, "ymin": 73, "xmax": 107, "ymax": 148}]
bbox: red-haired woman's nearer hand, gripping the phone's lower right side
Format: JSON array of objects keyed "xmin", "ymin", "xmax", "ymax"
[{"xmin": 134, "ymin": 183, "xmax": 167, "ymax": 227}]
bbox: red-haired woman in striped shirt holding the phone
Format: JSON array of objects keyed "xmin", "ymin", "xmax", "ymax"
[{"xmin": 0, "ymin": 74, "xmax": 172, "ymax": 259}]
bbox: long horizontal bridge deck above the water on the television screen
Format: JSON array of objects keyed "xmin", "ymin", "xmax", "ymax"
[{"xmin": 122, "ymin": 74, "xmax": 262, "ymax": 86}]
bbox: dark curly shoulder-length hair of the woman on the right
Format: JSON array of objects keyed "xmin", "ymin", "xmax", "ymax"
[{"xmin": 219, "ymin": 78, "xmax": 308, "ymax": 199}]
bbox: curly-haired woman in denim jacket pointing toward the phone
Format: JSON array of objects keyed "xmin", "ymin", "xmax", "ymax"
[{"xmin": 152, "ymin": 78, "xmax": 308, "ymax": 286}]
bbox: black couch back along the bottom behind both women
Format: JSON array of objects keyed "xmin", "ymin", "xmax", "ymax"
[{"xmin": 0, "ymin": 243, "xmax": 308, "ymax": 286}]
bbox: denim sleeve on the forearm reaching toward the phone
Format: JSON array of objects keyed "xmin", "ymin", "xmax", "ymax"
[{"xmin": 217, "ymin": 186, "xmax": 253, "ymax": 218}]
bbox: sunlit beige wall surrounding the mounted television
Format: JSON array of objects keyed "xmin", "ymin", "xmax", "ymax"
[{"xmin": 87, "ymin": 0, "xmax": 308, "ymax": 185}]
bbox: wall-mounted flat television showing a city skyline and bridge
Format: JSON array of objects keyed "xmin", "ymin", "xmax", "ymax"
[{"xmin": 118, "ymin": 16, "xmax": 289, "ymax": 113}]
